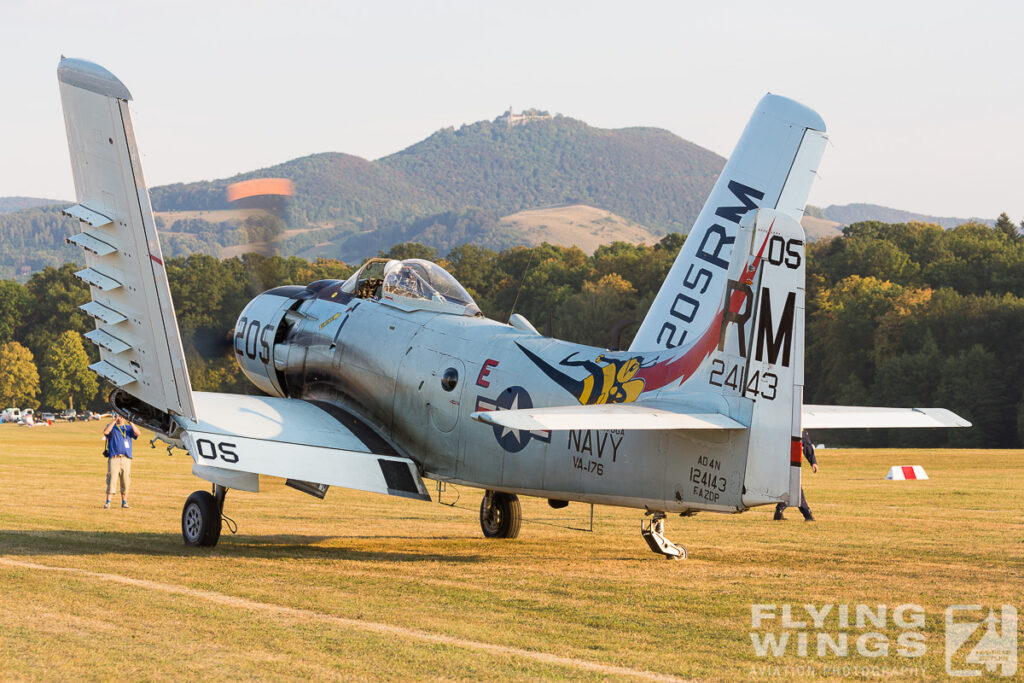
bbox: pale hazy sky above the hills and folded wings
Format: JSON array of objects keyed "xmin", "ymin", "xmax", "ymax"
[{"xmin": 6, "ymin": 0, "xmax": 1024, "ymax": 220}]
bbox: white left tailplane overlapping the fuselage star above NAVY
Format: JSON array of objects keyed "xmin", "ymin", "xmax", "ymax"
[{"xmin": 471, "ymin": 401, "xmax": 745, "ymax": 431}]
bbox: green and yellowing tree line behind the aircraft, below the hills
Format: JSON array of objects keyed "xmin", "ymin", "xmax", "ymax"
[{"xmin": 0, "ymin": 214, "xmax": 1024, "ymax": 447}]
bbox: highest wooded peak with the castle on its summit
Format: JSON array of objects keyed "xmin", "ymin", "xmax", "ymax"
[{"xmin": 378, "ymin": 117, "xmax": 725, "ymax": 233}]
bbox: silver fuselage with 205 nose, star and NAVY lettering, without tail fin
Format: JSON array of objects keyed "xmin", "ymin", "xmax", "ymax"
[{"xmin": 236, "ymin": 281, "xmax": 748, "ymax": 512}]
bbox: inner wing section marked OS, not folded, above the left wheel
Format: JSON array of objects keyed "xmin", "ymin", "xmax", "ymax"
[{"xmin": 177, "ymin": 391, "xmax": 430, "ymax": 501}]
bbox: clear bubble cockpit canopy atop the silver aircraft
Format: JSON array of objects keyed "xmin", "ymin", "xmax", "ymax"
[{"xmin": 341, "ymin": 258, "xmax": 480, "ymax": 315}]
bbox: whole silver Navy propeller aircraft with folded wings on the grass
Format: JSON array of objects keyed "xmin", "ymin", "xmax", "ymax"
[{"xmin": 57, "ymin": 59, "xmax": 968, "ymax": 557}]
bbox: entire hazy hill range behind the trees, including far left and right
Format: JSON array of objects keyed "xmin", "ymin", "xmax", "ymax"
[{"xmin": 0, "ymin": 113, "xmax": 1007, "ymax": 278}]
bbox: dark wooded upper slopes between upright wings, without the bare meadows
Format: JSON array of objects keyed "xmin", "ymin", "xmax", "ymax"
[{"xmin": 152, "ymin": 116, "xmax": 725, "ymax": 233}]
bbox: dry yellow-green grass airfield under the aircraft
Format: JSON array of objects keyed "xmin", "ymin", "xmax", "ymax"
[{"xmin": 0, "ymin": 423, "xmax": 1024, "ymax": 680}]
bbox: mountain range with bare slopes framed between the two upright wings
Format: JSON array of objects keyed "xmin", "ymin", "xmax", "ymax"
[{"xmin": 142, "ymin": 116, "xmax": 725, "ymax": 261}]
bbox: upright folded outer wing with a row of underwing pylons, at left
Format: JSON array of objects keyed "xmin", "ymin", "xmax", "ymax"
[{"xmin": 57, "ymin": 58, "xmax": 195, "ymax": 419}]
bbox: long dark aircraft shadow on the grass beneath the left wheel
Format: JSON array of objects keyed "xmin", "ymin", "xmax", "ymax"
[{"xmin": 0, "ymin": 529, "xmax": 485, "ymax": 562}]
